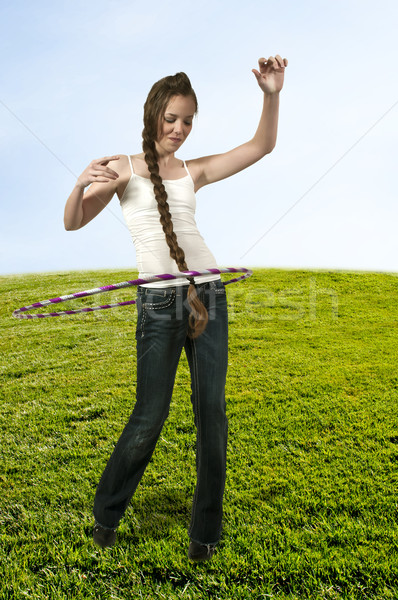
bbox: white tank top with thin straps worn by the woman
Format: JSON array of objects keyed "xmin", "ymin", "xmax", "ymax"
[{"xmin": 120, "ymin": 156, "xmax": 220, "ymax": 287}]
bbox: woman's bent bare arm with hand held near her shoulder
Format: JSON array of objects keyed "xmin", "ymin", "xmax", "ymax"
[{"xmin": 64, "ymin": 156, "xmax": 119, "ymax": 231}]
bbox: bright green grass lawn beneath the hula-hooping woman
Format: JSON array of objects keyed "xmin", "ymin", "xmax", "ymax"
[{"xmin": 0, "ymin": 269, "xmax": 398, "ymax": 600}]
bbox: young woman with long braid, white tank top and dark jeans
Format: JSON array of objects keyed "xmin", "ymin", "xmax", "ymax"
[{"xmin": 64, "ymin": 55, "xmax": 287, "ymax": 561}]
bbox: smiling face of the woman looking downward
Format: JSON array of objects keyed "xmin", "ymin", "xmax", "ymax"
[{"xmin": 156, "ymin": 96, "xmax": 196, "ymax": 152}]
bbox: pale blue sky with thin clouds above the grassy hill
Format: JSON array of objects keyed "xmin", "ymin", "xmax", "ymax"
[{"xmin": 0, "ymin": 0, "xmax": 398, "ymax": 276}]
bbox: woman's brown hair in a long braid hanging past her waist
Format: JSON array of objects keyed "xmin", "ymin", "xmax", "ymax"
[{"xmin": 142, "ymin": 73, "xmax": 209, "ymax": 339}]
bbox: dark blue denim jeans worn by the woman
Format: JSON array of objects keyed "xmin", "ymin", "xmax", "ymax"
[{"xmin": 94, "ymin": 280, "xmax": 228, "ymax": 544}]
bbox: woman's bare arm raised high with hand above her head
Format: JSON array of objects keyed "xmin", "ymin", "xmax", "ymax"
[{"xmin": 189, "ymin": 54, "xmax": 287, "ymax": 189}]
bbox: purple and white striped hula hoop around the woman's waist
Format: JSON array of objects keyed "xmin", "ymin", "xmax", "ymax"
[{"xmin": 12, "ymin": 267, "xmax": 253, "ymax": 319}]
